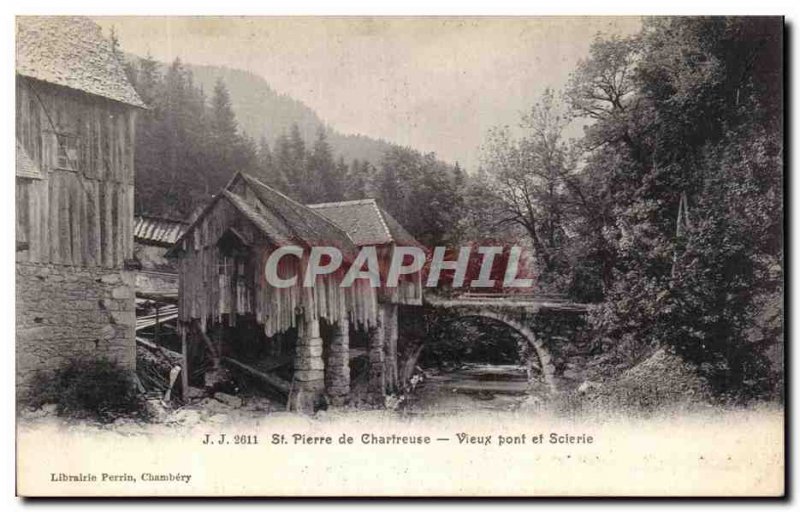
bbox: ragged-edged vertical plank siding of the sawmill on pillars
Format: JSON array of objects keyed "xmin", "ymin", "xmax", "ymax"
[{"xmin": 178, "ymin": 182, "xmax": 379, "ymax": 337}]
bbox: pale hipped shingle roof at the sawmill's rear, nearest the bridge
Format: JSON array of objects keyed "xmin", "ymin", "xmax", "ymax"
[{"xmin": 308, "ymin": 199, "xmax": 420, "ymax": 246}]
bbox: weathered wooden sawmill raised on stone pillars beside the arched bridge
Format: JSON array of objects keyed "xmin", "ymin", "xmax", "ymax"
[{"xmin": 170, "ymin": 173, "xmax": 421, "ymax": 412}]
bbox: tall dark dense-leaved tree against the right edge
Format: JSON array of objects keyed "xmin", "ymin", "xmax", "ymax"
[{"xmin": 584, "ymin": 18, "xmax": 782, "ymax": 396}]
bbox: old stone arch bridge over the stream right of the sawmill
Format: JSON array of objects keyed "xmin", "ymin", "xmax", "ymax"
[{"xmin": 425, "ymin": 293, "xmax": 596, "ymax": 392}]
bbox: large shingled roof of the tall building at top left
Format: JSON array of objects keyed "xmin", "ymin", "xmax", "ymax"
[{"xmin": 17, "ymin": 16, "xmax": 145, "ymax": 107}]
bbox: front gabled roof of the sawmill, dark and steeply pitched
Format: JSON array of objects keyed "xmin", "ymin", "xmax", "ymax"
[{"xmin": 176, "ymin": 173, "xmax": 358, "ymax": 261}]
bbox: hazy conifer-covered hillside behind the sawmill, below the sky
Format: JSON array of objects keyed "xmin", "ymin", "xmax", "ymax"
[{"xmin": 123, "ymin": 51, "xmax": 465, "ymax": 248}]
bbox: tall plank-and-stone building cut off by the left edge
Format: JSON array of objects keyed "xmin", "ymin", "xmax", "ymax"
[{"xmin": 16, "ymin": 17, "xmax": 145, "ymax": 392}]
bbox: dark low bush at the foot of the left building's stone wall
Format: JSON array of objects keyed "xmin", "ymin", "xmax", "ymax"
[{"xmin": 29, "ymin": 359, "xmax": 146, "ymax": 423}]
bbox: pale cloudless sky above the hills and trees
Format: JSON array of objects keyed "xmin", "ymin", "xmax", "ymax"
[{"xmin": 95, "ymin": 16, "xmax": 640, "ymax": 169}]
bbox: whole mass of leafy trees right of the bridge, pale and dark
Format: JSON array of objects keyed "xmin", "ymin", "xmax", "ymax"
[{"xmin": 476, "ymin": 18, "xmax": 783, "ymax": 396}]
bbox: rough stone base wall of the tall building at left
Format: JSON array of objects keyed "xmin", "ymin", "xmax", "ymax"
[{"xmin": 16, "ymin": 262, "xmax": 136, "ymax": 394}]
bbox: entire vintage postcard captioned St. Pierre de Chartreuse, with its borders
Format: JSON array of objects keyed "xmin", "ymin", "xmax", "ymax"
[{"xmin": 15, "ymin": 16, "xmax": 786, "ymax": 497}]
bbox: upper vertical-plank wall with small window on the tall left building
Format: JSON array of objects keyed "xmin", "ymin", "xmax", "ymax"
[{"xmin": 16, "ymin": 76, "xmax": 136, "ymax": 268}]
